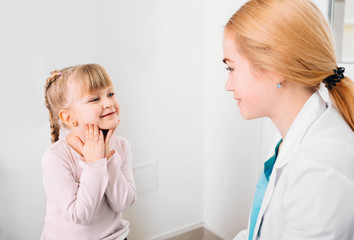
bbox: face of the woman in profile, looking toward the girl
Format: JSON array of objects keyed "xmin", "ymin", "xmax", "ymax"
[{"xmin": 223, "ymin": 34, "xmax": 279, "ymax": 119}]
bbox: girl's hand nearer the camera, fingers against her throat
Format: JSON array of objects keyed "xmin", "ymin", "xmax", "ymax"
[{"xmin": 76, "ymin": 124, "xmax": 105, "ymax": 163}]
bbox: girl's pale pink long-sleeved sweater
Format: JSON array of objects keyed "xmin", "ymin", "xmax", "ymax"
[{"xmin": 41, "ymin": 136, "xmax": 136, "ymax": 240}]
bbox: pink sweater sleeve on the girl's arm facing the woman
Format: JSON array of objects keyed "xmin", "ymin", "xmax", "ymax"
[{"xmin": 106, "ymin": 139, "xmax": 136, "ymax": 213}]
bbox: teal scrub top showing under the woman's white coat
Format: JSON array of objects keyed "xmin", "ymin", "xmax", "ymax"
[{"xmin": 248, "ymin": 139, "xmax": 282, "ymax": 240}]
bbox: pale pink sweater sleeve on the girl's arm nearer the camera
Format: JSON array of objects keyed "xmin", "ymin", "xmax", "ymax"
[{"xmin": 42, "ymin": 151, "xmax": 108, "ymax": 225}]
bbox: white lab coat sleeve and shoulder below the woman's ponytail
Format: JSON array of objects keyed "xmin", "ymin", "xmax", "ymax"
[{"xmin": 281, "ymin": 107, "xmax": 354, "ymax": 239}]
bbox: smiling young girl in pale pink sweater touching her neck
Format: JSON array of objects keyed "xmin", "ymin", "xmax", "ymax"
[{"xmin": 41, "ymin": 64, "xmax": 136, "ymax": 240}]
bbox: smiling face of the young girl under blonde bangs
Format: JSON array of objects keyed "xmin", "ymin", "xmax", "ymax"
[{"xmin": 71, "ymin": 82, "xmax": 119, "ymax": 129}]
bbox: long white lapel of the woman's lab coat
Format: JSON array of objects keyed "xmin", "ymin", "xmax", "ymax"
[{"xmin": 252, "ymin": 92, "xmax": 327, "ymax": 240}]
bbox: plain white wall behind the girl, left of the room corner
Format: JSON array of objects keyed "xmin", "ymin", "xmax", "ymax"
[{"xmin": 0, "ymin": 0, "xmax": 203, "ymax": 240}]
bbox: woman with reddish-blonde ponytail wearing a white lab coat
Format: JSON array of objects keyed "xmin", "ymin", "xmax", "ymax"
[{"xmin": 223, "ymin": 0, "xmax": 354, "ymax": 240}]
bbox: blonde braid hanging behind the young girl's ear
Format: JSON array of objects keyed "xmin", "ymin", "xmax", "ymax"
[{"xmin": 44, "ymin": 70, "xmax": 63, "ymax": 143}]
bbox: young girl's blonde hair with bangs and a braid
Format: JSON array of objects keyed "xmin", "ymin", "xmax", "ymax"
[{"xmin": 44, "ymin": 64, "xmax": 112, "ymax": 143}]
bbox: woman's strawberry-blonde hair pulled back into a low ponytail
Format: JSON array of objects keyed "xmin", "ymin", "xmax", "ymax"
[{"xmin": 225, "ymin": 0, "xmax": 354, "ymax": 131}]
